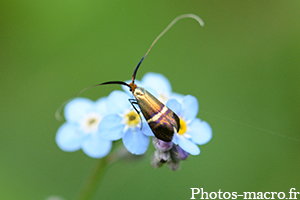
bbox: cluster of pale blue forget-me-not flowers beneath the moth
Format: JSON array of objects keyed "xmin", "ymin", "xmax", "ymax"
[{"xmin": 56, "ymin": 73, "xmax": 212, "ymax": 170}]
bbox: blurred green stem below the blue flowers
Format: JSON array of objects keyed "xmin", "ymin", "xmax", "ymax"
[{"xmin": 77, "ymin": 156, "xmax": 109, "ymax": 200}]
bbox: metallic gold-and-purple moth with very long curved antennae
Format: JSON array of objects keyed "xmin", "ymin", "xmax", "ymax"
[{"xmin": 56, "ymin": 14, "xmax": 204, "ymax": 142}]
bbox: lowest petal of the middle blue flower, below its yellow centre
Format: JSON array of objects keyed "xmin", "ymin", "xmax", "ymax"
[{"xmin": 123, "ymin": 127, "xmax": 150, "ymax": 155}]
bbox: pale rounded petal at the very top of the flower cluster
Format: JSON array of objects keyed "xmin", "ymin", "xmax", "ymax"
[{"xmin": 142, "ymin": 72, "xmax": 172, "ymax": 96}]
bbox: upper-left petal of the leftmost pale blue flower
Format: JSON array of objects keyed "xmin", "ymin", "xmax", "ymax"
[{"xmin": 64, "ymin": 97, "xmax": 94, "ymax": 123}]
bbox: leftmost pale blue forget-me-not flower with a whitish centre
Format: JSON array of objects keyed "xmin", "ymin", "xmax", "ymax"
[{"xmin": 55, "ymin": 97, "xmax": 112, "ymax": 158}]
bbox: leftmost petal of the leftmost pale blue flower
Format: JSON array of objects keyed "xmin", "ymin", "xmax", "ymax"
[{"xmin": 55, "ymin": 123, "xmax": 86, "ymax": 152}]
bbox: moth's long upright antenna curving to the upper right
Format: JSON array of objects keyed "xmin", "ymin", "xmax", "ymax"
[{"xmin": 132, "ymin": 14, "xmax": 204, "ymax": 83}]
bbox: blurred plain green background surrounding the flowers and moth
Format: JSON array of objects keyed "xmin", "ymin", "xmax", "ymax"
[{"xmin": 0, "ymin": 0, "xmax": 300, "ymax": 200}]
